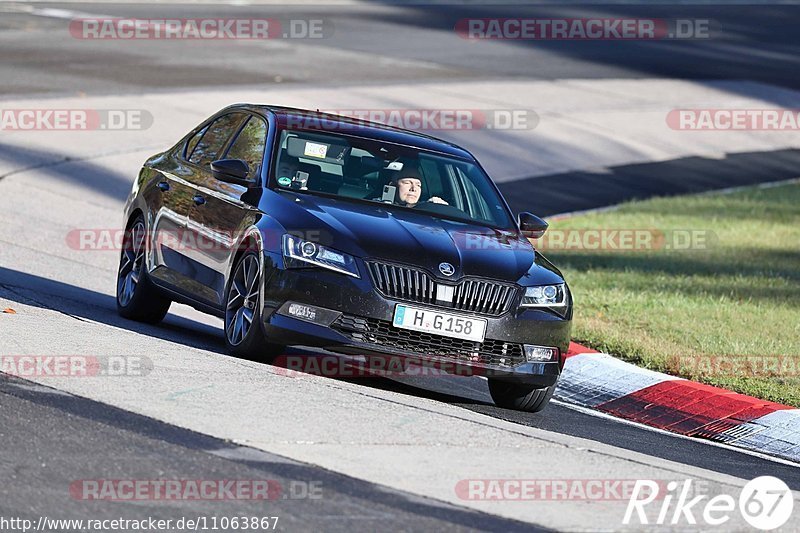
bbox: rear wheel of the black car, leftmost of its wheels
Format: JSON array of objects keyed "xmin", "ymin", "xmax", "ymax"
[{"xmin": 117, "ymin": 215, "xmax": 172, "ymax": 324}]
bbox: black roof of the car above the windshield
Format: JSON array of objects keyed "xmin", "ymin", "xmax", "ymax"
[{"xmin": 228, "ymin": 104, "xmax": 475, "ymax": 161}]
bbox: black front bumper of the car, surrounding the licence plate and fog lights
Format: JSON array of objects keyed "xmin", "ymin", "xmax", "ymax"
[{"xmin": 262, "ymin": 254, "xmax": 571, "ymax": 387}]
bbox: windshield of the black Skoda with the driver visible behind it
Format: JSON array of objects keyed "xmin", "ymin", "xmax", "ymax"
[{"xmin": 273, "ymin": 130, "xmax": 514, "ymax": 229}]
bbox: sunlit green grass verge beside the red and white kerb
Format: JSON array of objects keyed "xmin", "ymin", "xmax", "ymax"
[{"xmin": 540, "ymin": 183, "xmax": 800, "ymax": 407}]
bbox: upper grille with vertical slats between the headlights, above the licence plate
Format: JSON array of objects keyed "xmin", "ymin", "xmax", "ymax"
[{"xmin": 367, "ymin": 261, "xmax": 517, "ymax": 315}]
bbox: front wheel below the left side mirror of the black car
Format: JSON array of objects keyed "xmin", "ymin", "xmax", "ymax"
[{"xmin": 224, "ymin": 251, "xmax": 285, "ymax": 362}]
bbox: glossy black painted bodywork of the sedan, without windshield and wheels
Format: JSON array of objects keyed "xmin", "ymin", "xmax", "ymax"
[{"xmin": 125, "ymin": 105, "xmax": 572, "ymax": 387}]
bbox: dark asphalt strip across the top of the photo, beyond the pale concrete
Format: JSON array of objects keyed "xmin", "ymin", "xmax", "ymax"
[{"xmin": 0, "ymin": 2, "xmax": 800, "ymax": 94}]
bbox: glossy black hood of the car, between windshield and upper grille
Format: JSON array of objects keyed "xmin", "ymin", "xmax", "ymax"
[{"xmin": 280, "ymin": 192, "xmax": 560, "ymax": 284}]
